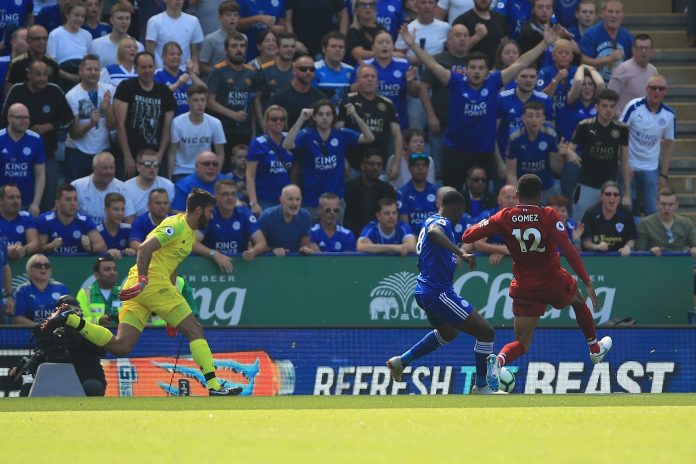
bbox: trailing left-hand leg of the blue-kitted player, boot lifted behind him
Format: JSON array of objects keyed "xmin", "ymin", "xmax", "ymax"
[{"xmin": 387, "ymin": 295, "xmax": 458, "ymax": 382}]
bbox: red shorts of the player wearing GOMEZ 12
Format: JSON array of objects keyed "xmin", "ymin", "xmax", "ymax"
[{"xmin": 510, "ymin": 269, "xmax": 578, "ymax": 317}]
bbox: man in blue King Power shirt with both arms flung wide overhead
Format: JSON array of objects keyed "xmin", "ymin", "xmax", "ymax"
[{"xmin": 401, "ymin": 20, "xmax": 568, "ymax": 189}]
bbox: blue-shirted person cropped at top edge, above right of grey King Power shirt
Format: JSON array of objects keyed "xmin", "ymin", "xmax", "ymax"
[{"xmin": 238, "ymin": 0, "xmax": 286, "ymax": 61}]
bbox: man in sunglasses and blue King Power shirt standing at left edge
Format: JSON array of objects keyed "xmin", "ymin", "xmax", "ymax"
[{"xmin": 0, "ymin": 103, "xmax": 46, "ymax": 216}]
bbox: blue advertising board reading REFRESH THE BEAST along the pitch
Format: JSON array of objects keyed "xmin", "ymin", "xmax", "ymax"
[{"xmin": 0, "ymin": 327, "xmax": 696, "ymax": 396}]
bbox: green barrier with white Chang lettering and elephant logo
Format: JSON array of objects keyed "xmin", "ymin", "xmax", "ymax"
[{"xmin": 6, "ymin": 250, "xmax": 694, "ymax": 327}]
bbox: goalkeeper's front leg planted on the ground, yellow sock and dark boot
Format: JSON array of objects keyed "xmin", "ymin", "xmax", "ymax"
[{"xmin": 165, "ymin": 304, "xmax": 242, "ymax": 396}]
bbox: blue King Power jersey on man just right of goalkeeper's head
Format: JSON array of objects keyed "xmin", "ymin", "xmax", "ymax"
[{"xmin": 203, "ymin": 206, "xmax": 259, "ymax": 256}]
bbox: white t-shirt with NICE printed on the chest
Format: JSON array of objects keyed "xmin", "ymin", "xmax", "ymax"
[{"xmin": 171, "ymin": 112, "xmax": 227, "ymax": 174}]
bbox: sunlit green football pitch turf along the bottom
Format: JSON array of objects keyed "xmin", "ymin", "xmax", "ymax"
[{"xmin": 0, "ymin": 394, "xmax": 696, "ymax": 464}]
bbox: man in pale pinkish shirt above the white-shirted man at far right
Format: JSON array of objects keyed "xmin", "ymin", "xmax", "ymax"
[{"xmin": 607, "ymin": 34, "xmax": 658, "ymax": 114}]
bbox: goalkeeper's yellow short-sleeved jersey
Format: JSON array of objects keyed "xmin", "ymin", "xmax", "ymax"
[{"xmin": 128, "ymin": 213, "xmax": 195, "ymax": 283}]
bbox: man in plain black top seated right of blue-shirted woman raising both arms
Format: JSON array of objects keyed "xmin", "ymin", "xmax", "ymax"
[{"xmin": 343, "ymin": 148, "xmax": 396, "ymax": 236}]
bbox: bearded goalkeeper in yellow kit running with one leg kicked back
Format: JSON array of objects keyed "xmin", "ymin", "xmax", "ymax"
[{"xmin": 41, "ymin": 189, "xmax": 242, "ymax": 396}]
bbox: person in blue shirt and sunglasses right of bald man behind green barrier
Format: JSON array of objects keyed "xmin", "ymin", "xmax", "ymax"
[{"xmin": 312, "ymin": 193, "xmax": 355, "ymax": 253}]
